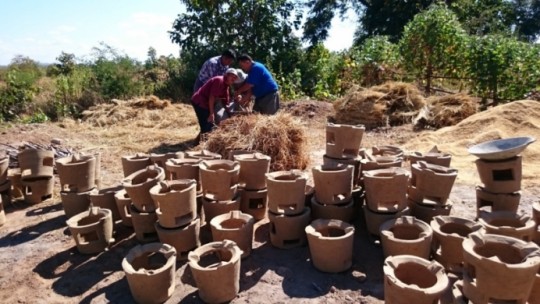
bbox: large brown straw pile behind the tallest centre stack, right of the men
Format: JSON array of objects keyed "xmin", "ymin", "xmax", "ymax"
[{"xmin": 334, "ymin": 82, "xmax": 425, "ymax": 129}]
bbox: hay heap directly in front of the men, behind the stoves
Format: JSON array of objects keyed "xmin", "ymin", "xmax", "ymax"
[{"xmin": 202, "ymin": 113, "xmax": 309, "ymax": 171}]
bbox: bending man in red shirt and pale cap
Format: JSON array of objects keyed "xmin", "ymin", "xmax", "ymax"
[{"xmin": 191, "ymin": 68, "xmax": 238, "ymax": 135}]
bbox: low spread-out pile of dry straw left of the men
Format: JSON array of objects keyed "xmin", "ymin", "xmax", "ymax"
[{"xmin": 82, "ymin": 96, "xmax": 197, "ymax": 129}]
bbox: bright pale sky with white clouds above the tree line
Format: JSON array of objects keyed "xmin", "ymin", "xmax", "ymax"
[{"xmin": 0, "ymin": 0, "xmax": 355, "ymax": 65}]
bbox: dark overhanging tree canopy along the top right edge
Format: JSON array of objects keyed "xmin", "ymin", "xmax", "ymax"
[{"xmin": 303, "ymin": 0, "xmax": 540, "ymax": 45}]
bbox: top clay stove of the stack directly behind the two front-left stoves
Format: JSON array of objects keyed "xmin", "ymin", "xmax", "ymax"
[{"xmin": 150, "ymin": 179, "xmax": 197, "ymax": 228}]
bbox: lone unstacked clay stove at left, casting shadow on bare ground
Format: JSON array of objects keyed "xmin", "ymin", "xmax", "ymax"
[{"xmin": 66, "ymin": 207, "xmax": 114, "ymax": 254}]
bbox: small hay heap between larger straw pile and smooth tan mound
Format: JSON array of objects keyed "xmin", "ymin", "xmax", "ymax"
[{"xmin": 414, "ymin": 94, "xmax": 478, "ymax": 129}]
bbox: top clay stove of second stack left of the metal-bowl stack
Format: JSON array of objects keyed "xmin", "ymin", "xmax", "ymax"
[{"xmin": 364, "ymin": 167, "xmax": 409, "ymax": 213}]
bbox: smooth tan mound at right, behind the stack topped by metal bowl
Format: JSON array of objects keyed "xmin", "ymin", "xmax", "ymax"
[{"xmin": 403, "ymin": 100, "xmax": 540, "ymax": 186}]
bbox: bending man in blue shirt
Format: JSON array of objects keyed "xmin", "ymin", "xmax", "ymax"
[{"xmin": 237, "ymin": 54, "xmax": 279, "ymax": 115}]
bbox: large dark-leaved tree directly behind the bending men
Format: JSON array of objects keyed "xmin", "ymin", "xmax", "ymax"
[{"xmin": 169, "ymin": 0, "xmax": 301, "ymax": 95}]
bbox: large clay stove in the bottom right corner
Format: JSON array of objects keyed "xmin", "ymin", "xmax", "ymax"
[{"xmin": 463, "ymin": 232, "xmax": 540, "ymax": 303}]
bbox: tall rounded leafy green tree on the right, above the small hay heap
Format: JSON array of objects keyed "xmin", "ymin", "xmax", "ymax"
[{"xmin": 399, "ymin": 5, "xmax": 468, "ymax": 94}]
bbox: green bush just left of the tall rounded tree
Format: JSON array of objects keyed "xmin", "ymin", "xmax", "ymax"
[{"xmin": 351, "ymin": 36, "xmax": 401, "ymax": 86}]
